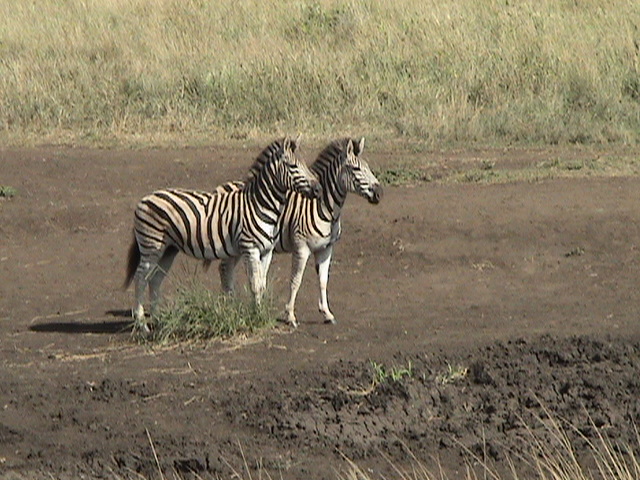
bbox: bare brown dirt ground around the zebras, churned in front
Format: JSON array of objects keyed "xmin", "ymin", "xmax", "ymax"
[{"xmin": 0, "ymin": 145, "xmax": 640, "ymax": 480}]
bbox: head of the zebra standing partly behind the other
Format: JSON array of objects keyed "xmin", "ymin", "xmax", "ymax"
[{"xmin": 341, "ymin": 137, "xmax": 383, "ymax": 204}]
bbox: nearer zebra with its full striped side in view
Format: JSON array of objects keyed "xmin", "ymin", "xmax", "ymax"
[{"xmin": 124, "ymin": 137, "xmax": 321, "ymax": 334}]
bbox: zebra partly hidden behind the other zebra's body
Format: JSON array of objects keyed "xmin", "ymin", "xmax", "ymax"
[{"xmin": 212, "ymin": 137, "xmax": 383, "ymax": 327}]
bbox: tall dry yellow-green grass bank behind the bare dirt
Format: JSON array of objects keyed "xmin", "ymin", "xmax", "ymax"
[{"xmin": 0, "ymin": 0, "xmax": 640, "ymax": 146}]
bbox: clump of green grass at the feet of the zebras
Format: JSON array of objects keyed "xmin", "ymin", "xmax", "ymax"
[{"xmin": 150, "ymin": 282, "xmax": 277, "ymax": 344}]
